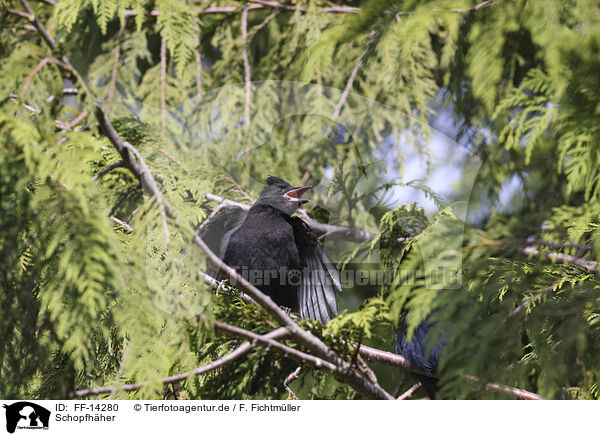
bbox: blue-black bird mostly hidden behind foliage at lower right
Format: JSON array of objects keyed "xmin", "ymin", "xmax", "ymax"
[{"xmin": 396, "ymin": 318, "xmax": 446, "ymax": 400}]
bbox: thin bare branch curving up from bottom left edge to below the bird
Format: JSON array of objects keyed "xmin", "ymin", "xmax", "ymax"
[{"xmin": 69, "ymin": 328, "xmax": 288, "ymax": 398}]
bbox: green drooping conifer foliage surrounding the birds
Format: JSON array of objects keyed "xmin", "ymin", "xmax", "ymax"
[{"xmin": 0, "ymin": 0, "xmax": 600, "ymax": 399}]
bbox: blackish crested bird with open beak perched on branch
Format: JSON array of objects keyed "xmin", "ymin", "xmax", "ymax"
[{"xmin": 200, "ymin": 176, "xmax": 342, "ymax": 323}]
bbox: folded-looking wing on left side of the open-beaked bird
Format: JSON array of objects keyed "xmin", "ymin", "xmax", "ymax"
[{"xmin": 198, "ymin": 206, "xmax": 248, "ymax": 277}]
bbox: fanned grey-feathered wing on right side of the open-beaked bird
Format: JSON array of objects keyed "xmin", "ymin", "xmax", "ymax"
[{"xmin": 290, "ymin": 217, "xmax": 342, "ymax": 323}]
